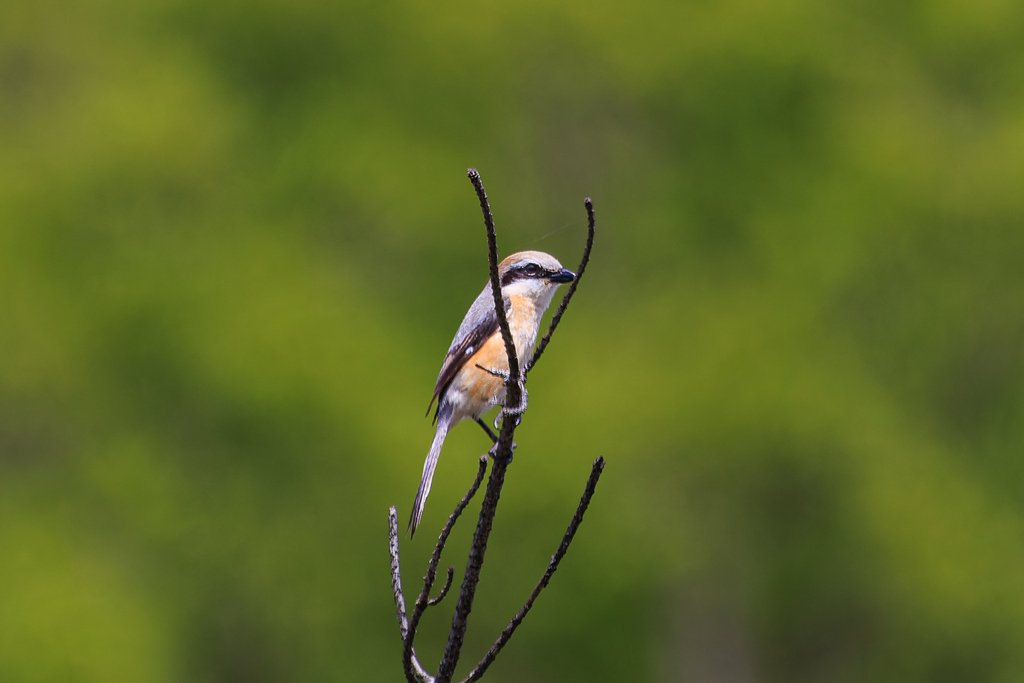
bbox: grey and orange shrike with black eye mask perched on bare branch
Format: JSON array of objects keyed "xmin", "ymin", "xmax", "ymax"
[{"xmin": 409, "ymin": 251, "xmax": 575, "ymax": 538}]
